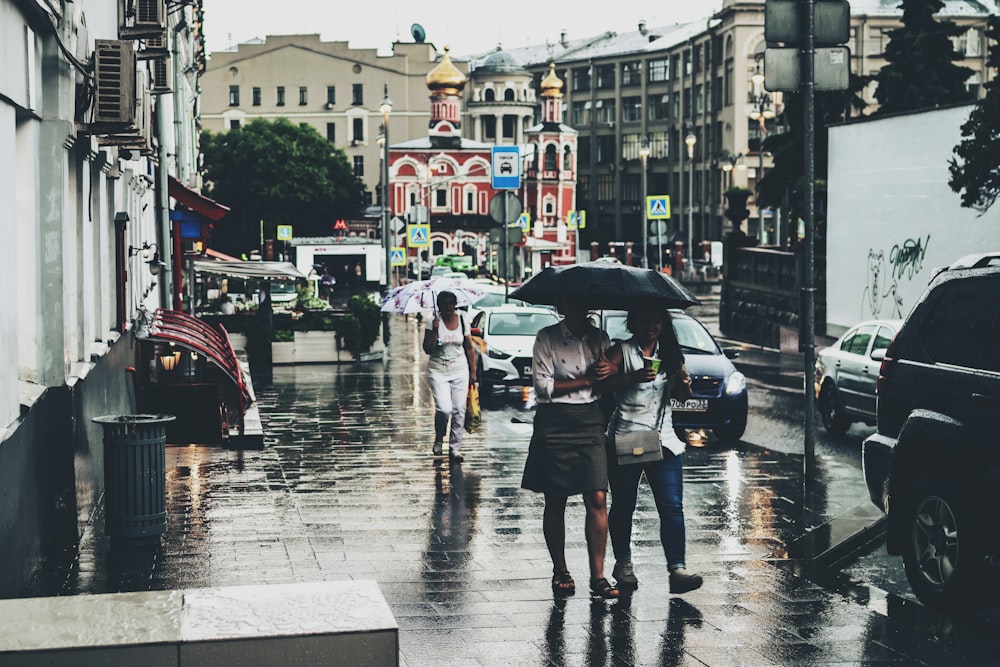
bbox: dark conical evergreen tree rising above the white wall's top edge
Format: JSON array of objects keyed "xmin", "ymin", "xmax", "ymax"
[{"xmin": 875, "ymin": 0, "xmax": 972, "ymax": 115}]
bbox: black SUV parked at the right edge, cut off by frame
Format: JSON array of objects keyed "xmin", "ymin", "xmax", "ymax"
[{"xmin": 863, "ymin": 253, "xmax": 1000, "ymax": 610}]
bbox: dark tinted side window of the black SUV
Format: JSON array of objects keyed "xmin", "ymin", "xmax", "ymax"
[{"xmin": 920, "ymin": 277, "xmax": 1000, "ymax": 368}]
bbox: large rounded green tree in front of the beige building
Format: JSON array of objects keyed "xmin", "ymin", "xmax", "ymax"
[{"xmin": 201, "ymin": 118, "xmax": 364, "ymax": 255}]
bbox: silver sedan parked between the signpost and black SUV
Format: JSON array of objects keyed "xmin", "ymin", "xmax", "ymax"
[{"xmin": 814, "ymin": 320, "xmax": 903, "ymax": 435}]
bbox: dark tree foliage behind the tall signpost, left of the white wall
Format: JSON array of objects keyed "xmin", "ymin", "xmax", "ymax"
[{"xmin": 757, "ymin": 74, "xmax": 871, "ymax": 220}]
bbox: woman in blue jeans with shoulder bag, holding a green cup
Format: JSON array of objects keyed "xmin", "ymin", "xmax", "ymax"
[{"xmin": 607, "ymin": 305, "xmax": 702, "ymax": 593}]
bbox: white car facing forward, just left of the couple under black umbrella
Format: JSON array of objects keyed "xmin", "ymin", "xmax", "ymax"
[{"xmin": 472, "ymin": 304, "xmax": 559, "ymax": 396}]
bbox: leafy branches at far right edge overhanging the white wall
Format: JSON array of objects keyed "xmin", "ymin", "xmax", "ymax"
[{"xmin": 948, "ymin": 16, "xmax": 1000, "ymax": 214}]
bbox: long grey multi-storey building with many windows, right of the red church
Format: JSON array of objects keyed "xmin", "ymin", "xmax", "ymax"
[{"xmin": 486, "ymin": 0, "xmax": 997, "ymax": 263}]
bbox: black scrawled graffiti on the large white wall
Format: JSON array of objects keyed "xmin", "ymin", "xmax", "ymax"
[{"xmin": 861, "ymin": 234, "xmax": 931, "ymax": 319}]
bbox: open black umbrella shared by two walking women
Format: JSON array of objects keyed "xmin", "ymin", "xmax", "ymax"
[{"xmin": 510, "ymin": 261, "xmax": 701, "ymax": 309}]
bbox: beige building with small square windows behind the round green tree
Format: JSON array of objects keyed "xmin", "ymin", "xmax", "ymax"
[{"xmin": 201, "ymin": 35, "xmax": 468, "ymax": 213}]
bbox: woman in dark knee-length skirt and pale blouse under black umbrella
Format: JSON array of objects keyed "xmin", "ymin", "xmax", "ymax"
[{"xmin": 521, "ymin": 301, "xmax": 619, "ymax": 599}]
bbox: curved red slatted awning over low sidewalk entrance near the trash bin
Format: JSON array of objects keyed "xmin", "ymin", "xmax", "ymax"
[{"xmin": 149, "ymin": 308, "xmax": 253, "ymax": 419}]
